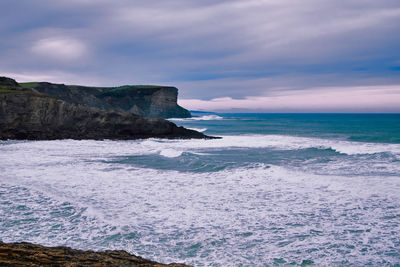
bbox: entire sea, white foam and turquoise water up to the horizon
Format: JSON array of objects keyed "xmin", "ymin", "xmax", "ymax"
[{"xmin": 0, "ymin": 114, "xmax": 400, "ymax": 266}]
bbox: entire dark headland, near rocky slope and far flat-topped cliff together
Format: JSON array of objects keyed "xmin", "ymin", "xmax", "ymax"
[{"xmin": 0, "ymin": 77, "xmax": 216, "ymax": 140}]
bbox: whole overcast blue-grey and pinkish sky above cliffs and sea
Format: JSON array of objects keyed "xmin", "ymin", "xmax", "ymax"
[{"xmin": 0, "ymin": 0, "xmax": 400, "ymax": 112}]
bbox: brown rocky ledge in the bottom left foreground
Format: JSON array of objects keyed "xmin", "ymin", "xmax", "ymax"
[{"xmin": 0, "ymin": 241, "xmax": 188, "ymax": 267}]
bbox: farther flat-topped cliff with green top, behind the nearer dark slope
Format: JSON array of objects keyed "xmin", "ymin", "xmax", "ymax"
[{"xmin": 21, "ymin": 82, "xmax": 191, "ymax": 118}]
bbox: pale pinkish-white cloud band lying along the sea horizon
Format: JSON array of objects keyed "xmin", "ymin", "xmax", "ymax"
[{"xmin": 179, "ymin": 85, "xmax": 400, "ymax": 112}]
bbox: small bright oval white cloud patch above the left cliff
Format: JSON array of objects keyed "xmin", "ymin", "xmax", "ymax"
[{"xmin": 32, "ymin": 37, "xmax": 88, "ymax": 62}]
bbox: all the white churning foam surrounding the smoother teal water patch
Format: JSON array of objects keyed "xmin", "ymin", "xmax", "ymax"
[{"xmin": 0, "ymin": 139, "xmax": 400, "ymax": 266}]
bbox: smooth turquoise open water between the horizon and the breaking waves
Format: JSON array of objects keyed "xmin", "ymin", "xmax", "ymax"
[{"xmin": 183, "ymin": 113, "xmax": 400, "ymax": 143}]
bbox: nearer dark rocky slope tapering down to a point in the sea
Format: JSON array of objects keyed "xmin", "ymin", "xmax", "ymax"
[{"xmin": 0, "ymin": 77, "xmax": 208, "ymax": 140}]
